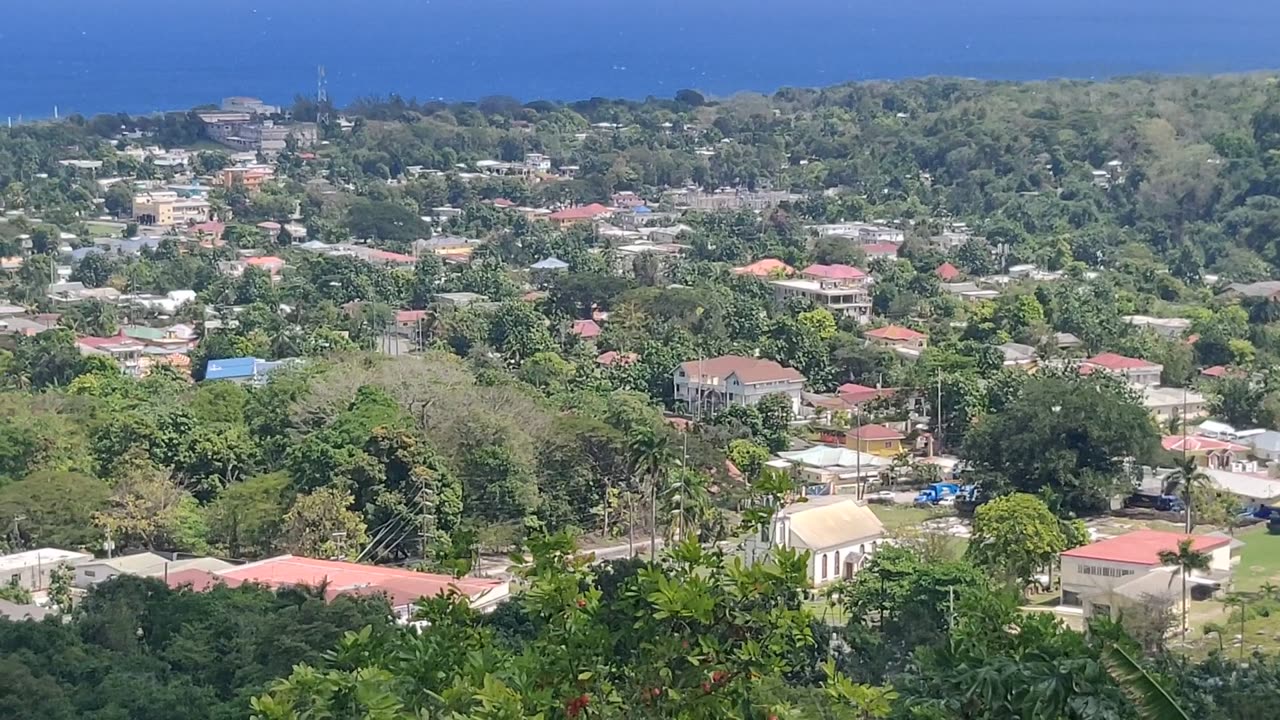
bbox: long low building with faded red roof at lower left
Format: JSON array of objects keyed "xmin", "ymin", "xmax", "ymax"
[{"xmin": 168, "ymin": 555, "xmax": 511, "ymax": 614}]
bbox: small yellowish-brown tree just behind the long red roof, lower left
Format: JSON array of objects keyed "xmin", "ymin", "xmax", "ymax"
[{"xmin": 280, "ymin": 487, "xmax": 369, "ymax": 560}]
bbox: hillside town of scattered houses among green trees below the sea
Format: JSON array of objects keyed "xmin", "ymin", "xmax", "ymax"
[{"xmin": 0, "ymin": 78, "xmax": 1280, "ymax": 720}]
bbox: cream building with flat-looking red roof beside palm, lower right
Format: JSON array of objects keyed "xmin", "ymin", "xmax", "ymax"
[{"xmin": 1059, "ymin": 530, "xmax": 1235, "ymax": 619}]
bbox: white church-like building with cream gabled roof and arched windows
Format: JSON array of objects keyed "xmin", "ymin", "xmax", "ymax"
[{"xmin": 746, "ymin": 495, "xmax": 884, "ymax": 587}]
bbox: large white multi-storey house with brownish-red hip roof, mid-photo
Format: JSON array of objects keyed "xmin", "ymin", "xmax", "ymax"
[{"xmin": 672, "ymin": 355, "xmax": 805, "ymax": 416}]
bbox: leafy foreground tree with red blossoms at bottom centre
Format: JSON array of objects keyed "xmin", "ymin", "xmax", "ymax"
[{"xmin": 252, "ymin": 537, "xmax": 896, "ymax": 720}]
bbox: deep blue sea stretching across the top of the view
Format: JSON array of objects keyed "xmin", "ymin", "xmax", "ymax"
[{"xmin": 0, "ymin": 0, "xmax": 1280, "ymax": 120}]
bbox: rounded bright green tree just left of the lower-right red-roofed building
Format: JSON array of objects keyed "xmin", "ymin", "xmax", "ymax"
[{"xmin": 965, "ymin": 493, "xmax": 1066, "ymax": 591}]
